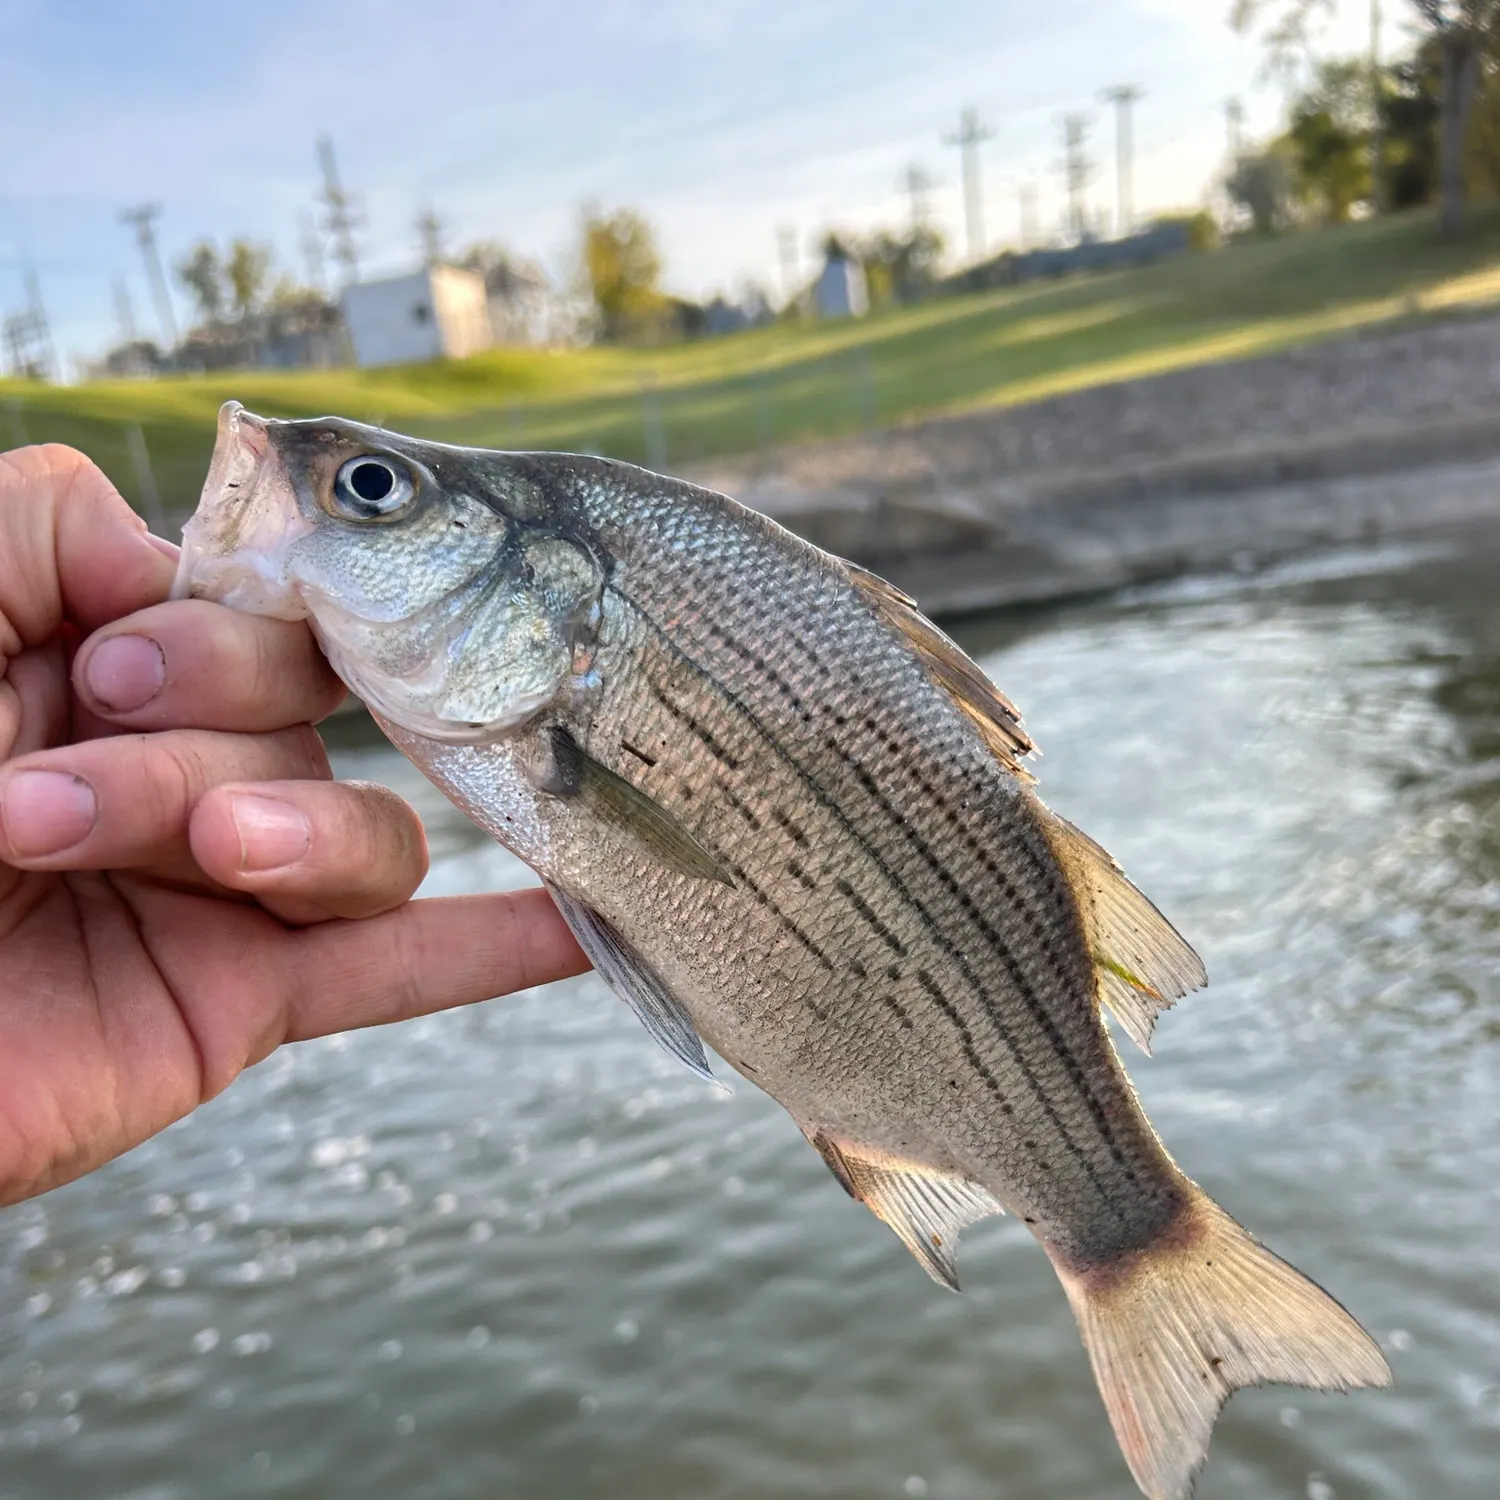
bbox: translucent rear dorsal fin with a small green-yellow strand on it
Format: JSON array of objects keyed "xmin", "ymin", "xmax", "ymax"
[{"xmin": 1037, "ymin": 803, "xmax": 1209, "ymax": 1053}]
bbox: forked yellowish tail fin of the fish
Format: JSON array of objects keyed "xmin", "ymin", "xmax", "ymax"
[{"xmin": 1058, "ymin": 1185, "xmax": 1391, "ymax": 1500}]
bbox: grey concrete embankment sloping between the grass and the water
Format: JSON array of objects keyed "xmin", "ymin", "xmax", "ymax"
[{"xmin": 690, "ymin": 318, "xmax": 1500, "ymax": 614}]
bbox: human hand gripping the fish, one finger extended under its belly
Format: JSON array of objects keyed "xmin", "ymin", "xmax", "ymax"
[{"xmin": 0, "ymin": 447, "xmax": 587, "ymax": 1203}]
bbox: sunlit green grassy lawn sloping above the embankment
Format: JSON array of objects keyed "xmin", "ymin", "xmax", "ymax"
[{"xmin": 0, "ymin": 210, "xmax": 1500, "ymax": 509}]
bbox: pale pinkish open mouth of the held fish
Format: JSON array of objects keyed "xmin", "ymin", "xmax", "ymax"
[{"xmin": 171, "ymin": 401, "xmax": 314, "ymax": 620}]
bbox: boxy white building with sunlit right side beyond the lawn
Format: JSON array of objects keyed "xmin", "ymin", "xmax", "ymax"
[{"xmin": 339, "ymin": 266, "xmax": 491, "ymax": 366}]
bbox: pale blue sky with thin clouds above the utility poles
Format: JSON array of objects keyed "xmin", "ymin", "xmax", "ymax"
[{"xmin": 0, "ymin": 0, "xmax": 1404, "ymax": 372}]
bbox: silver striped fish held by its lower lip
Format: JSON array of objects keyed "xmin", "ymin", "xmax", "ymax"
[{"xmin": 177, "ymin": 402, "xmax": 1391, "ymax": 1500}]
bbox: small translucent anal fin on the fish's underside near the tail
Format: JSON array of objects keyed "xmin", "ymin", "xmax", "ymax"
[{"xmin": 803, "ymin": 1125, "xmax": 1005, "ymax": 1292}]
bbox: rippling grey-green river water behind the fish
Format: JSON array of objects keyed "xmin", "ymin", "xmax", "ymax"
[{"xmin": 0, "ymin": 542, "xmax": 1500, "ymax": 1500}]
